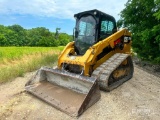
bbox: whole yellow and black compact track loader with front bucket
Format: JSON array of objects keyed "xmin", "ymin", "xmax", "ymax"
[{"xmin": 25, "ymin": 9, "xmax": 133, "ymax": 116}]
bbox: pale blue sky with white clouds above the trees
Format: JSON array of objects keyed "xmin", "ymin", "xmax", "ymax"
[{"xmin": 0, "ymin": 0, "xmax": 127, "ymax": 35}]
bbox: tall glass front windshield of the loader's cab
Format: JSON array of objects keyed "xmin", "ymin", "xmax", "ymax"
[{"xmin": 75, "ymin": 15, "xmax": 96, "ymax": 55}]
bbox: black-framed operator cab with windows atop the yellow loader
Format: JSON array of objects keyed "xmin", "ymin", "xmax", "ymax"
[{"xmin": 74, "ymin": 9, "xmax": 117, "ymax": 55}]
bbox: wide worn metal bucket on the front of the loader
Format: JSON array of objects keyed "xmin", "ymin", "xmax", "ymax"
[{"xmin": 25, "ymin": 67, "xmax": 100, "ymax": 116}]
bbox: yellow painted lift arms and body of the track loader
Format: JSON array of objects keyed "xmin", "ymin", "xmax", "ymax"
[{"xmin": 58, "ymin": 29, "xmax": 131, "ymax": 76}]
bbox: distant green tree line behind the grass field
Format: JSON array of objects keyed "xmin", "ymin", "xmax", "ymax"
[{"xmin": 0, "ymin": 24, "xmax": 72, "ymax": 47}]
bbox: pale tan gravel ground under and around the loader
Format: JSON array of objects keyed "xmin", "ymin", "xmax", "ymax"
[{"xmin": 0, "ymin": 66, "xmax": 160, "ymax": 120}]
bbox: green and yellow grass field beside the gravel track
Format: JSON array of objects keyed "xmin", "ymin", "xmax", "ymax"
[{"xmin": 0, "ymin": 47, "xmax": 64, "ymax": 83}]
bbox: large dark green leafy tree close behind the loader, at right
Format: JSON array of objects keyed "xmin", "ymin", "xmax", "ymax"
[{"xmin": 117, "ymin": 0, "xmax": 160, "ymax": 64}]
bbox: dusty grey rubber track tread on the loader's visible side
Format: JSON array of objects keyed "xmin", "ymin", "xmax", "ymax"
[{"xmin": 92, "ymin": 53, "xmax": 129, "ymax": 91}]
